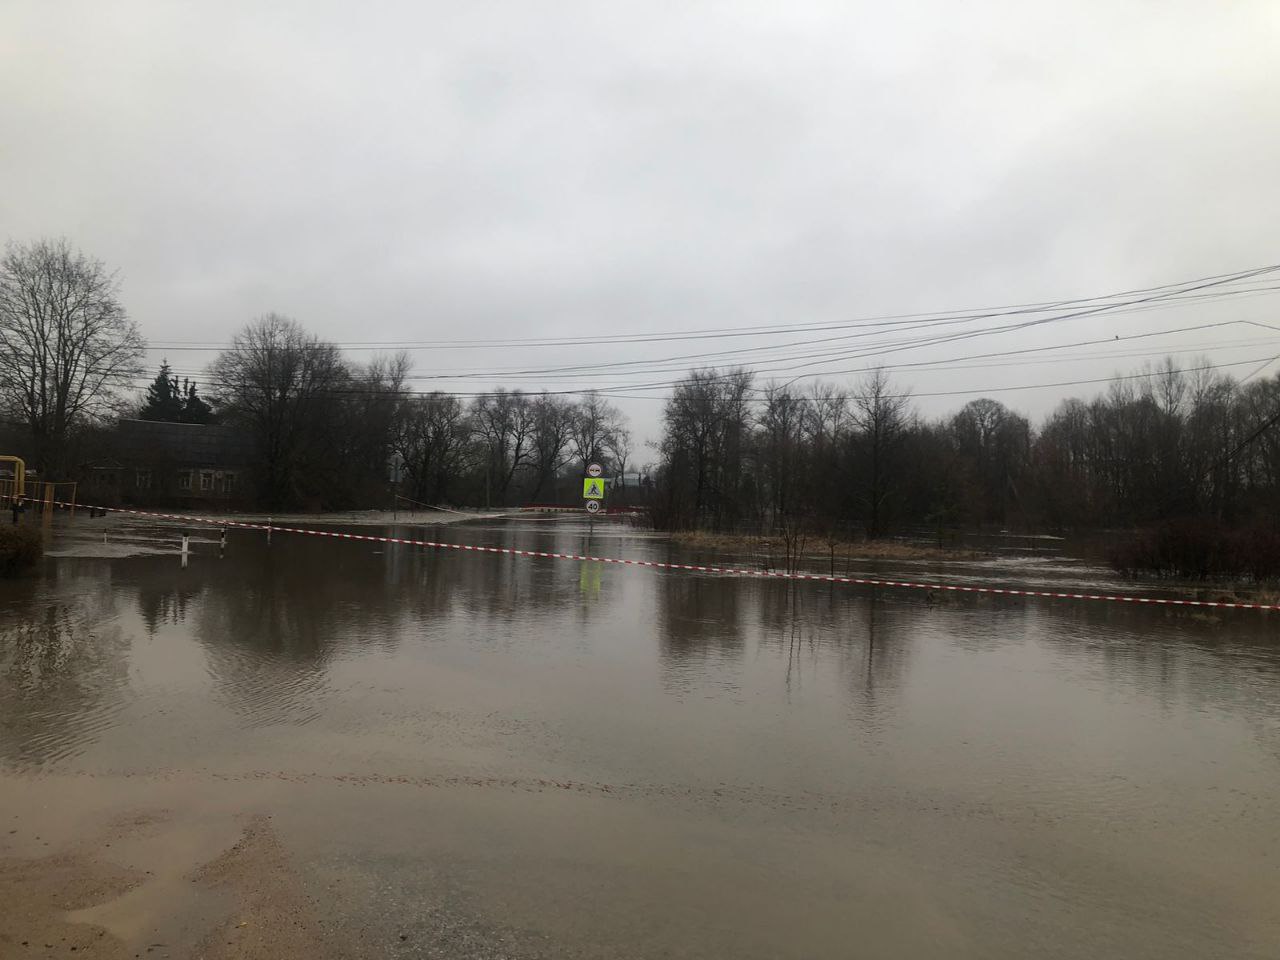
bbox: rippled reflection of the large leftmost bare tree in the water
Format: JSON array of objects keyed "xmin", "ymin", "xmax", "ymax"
[{"xmin": 0, "ymin": 591, "xmax": 129, "ymax": 768}]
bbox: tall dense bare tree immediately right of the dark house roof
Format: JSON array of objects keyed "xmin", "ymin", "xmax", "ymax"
[{"xmin": 210, "ymin": 314, "xmax": 353, "ymax": 508}]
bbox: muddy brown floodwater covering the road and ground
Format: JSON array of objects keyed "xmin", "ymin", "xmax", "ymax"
[{"xmin": 0, "ymin": 517, "xmax": 1280, "ymax": 960}]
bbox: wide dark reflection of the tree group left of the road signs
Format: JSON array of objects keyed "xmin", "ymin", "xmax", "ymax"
[{"xmin": 183, "ymin": 529, "xmax": 576, "ymax": 723}]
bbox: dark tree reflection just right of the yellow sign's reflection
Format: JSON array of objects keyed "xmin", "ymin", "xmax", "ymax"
[{"xmin": 657, "ymin": 575, "xmax": 749, "ymax": 691}]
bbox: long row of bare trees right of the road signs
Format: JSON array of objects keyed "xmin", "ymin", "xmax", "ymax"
[{"xmin": 654, "ymin": 358, "xmax": 1280, "ymax": 539}]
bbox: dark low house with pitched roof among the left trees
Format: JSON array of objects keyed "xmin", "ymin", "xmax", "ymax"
[{"xmin": 78, "ymin": 420, "xmax": 253, "ymax": 507}]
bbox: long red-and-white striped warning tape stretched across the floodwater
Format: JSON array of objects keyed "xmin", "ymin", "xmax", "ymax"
[{"xmin": 42, "ymin": 500, "xmax": 1280, "ymax": 611}]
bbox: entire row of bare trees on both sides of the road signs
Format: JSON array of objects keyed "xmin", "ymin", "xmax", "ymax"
[{"xmin": 0, "ymin": 241, "xmax": 1280, "ymax": 553}]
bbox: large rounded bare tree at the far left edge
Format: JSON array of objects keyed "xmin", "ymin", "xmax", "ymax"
[{"xmin": 0, "ymin": 239, "xmax": 143, "ymax": 476}]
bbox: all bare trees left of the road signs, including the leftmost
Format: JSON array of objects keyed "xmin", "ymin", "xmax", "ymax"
[{"xmin": 0, "ymin": 239, "xmax": 631, "ymax": 509}]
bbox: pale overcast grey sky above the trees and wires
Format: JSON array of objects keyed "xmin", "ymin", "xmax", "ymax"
[{"xmin": 0, "ymin": 0, "xmax": 1280, "ymax": 450}]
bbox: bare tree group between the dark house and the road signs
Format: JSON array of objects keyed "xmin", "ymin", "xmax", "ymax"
[{"xmin": 209, "ymin": 314, "xmax": 631, "ymax": 508}]
